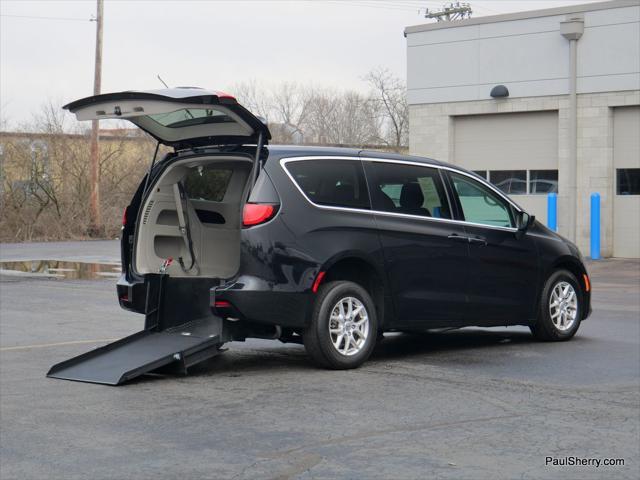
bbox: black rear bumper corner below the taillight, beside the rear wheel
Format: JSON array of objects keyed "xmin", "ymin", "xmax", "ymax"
[{"xmin": 210, "ymin": 278, "xmax": 313, "ymax": 328}]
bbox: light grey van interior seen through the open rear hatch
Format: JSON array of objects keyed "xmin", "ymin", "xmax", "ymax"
[{"xmin": 133, "ymin": 156, "xmax": 253, "ymax": 279}]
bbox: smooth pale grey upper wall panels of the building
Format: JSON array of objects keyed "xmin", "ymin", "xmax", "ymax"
[{"xmin": 407, "ymin": 2, "xmax": 640, "ymax": 104}]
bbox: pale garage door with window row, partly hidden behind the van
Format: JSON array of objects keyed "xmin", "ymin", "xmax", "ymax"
[{"xmin": 453, "ymin": 111, "xmax": 558, "ymax": 223}]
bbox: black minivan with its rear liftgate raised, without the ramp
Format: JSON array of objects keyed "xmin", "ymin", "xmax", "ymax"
[{"xmin": 56, "ymin": 88, "xmax": 591, "ymax": 376}]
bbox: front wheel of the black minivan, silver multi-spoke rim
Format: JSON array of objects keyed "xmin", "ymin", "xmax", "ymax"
[{"xmin": 530, "ymin": 270, "xmax": 582, "ymax": 342}]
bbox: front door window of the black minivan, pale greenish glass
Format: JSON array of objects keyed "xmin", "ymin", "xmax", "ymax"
[{"xmin": 451, "ymin": 172, "xmax": 514, "ymax": 227}]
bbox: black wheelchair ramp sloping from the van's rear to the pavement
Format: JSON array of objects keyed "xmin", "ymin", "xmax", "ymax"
[{"xmin": 47, "ymin": 318, "xmax": 221, "ymax": 385}]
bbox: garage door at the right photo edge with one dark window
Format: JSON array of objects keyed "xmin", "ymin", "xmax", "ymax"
[{"xmin": 613, "ymin": 106, "xmax": 640, "ymax": 258}]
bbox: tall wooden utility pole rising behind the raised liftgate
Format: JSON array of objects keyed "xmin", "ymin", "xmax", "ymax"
[{"xmin": 88, "ymin": 0, "xmax": 104, "ymax": 237}]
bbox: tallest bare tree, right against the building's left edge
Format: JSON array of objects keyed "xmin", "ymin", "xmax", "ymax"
[{"xmin": 365, "ymin": 67, "xmax": 409, "ymax": 149}]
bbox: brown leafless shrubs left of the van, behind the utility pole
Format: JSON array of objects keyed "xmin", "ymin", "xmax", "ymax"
[{"xmin": 0, "ymin": 104, "xmax": 154, "ymax": 241}]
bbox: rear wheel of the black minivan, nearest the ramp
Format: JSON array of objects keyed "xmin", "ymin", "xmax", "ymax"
[{"xmin": 302, "ymin": 281, "xmax": 378, "ymax": 370}]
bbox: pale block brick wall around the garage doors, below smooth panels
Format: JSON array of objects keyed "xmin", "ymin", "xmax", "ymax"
[{"xmin": 409, "ymin": 90, "xmax": 640, "ymax": 256}]
